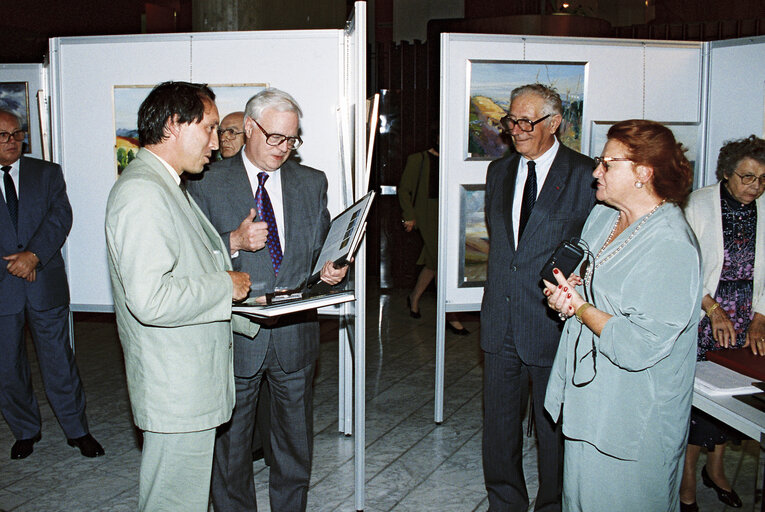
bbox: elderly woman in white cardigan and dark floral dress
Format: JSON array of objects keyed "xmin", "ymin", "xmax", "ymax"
[{"xmin": 680, "ymin": 135, "xmax": 765, "ymax": 512}]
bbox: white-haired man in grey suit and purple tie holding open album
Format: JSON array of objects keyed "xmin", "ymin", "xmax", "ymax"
[{"xmin": 189, "ymin": 89, "xmax": 347, "ymax": 512}]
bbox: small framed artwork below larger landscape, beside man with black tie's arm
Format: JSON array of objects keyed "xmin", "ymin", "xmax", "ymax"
[{"xmin": 458, "ymin": 184, "xmax": 489, "ymax": 288}]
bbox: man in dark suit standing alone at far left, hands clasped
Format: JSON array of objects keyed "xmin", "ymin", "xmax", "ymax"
[{"xmin": 0, "ymin": 110, "xmax": 104, "ymax": 459}]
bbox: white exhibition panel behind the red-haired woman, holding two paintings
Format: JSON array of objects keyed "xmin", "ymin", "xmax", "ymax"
[{"xmin": 438, "ymin": 34, "xmax": 700, "ymax": 311}]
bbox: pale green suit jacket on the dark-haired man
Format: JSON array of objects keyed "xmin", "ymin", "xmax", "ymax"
[{"xmin": 106, "ymin": 149, "xmax": 257, "ymax": 432}]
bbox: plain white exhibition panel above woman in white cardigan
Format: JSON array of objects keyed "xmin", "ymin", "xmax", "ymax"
[{"xmin": 704, "ymin": 36, "xmax": 765, "ymax": 185}]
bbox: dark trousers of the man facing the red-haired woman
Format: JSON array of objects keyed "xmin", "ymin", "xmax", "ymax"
[{"xmin": 483, "ymin": 337, "xmax": 563, "ymax": 512}]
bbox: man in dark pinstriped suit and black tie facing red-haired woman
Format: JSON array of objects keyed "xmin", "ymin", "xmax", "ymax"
[{"xmin": 481, "ymin": 84, "xmax": 595, "ymax": 512}]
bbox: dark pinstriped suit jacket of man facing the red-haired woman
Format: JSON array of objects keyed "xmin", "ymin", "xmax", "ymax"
[{"xmin": 481, "ymin": 144, "xmax": 595, "ymax": 366}]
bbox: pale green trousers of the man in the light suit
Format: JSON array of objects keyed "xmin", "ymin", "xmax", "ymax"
[{"xmin": 138, "ymin": 428, "xmax": 215, "ymax": 512}]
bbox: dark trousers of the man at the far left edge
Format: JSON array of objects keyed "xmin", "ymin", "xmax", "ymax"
[{"xmin": 0, "ymin": 304, "xmax": 88, "ymax": 439}]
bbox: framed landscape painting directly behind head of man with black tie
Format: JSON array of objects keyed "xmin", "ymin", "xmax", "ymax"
[{"xmin": 467, "ymin": 61, "xmax": 585, "ymax": 160}]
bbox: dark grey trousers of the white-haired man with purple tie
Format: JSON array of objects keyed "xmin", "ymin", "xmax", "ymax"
[{"xmin": 212, "ymin": 341, "xmax": 314, "ymax": 512}]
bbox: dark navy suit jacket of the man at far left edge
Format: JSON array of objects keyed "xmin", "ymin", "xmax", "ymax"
[{"xmin": 0, "ymin": 157, "xmax": 72, "ymax": 315}]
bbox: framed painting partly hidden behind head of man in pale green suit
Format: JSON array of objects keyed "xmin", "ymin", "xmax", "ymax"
[{"xmin": 114, "ymin": 83, "xmax": 268, "ymax": 176}]
